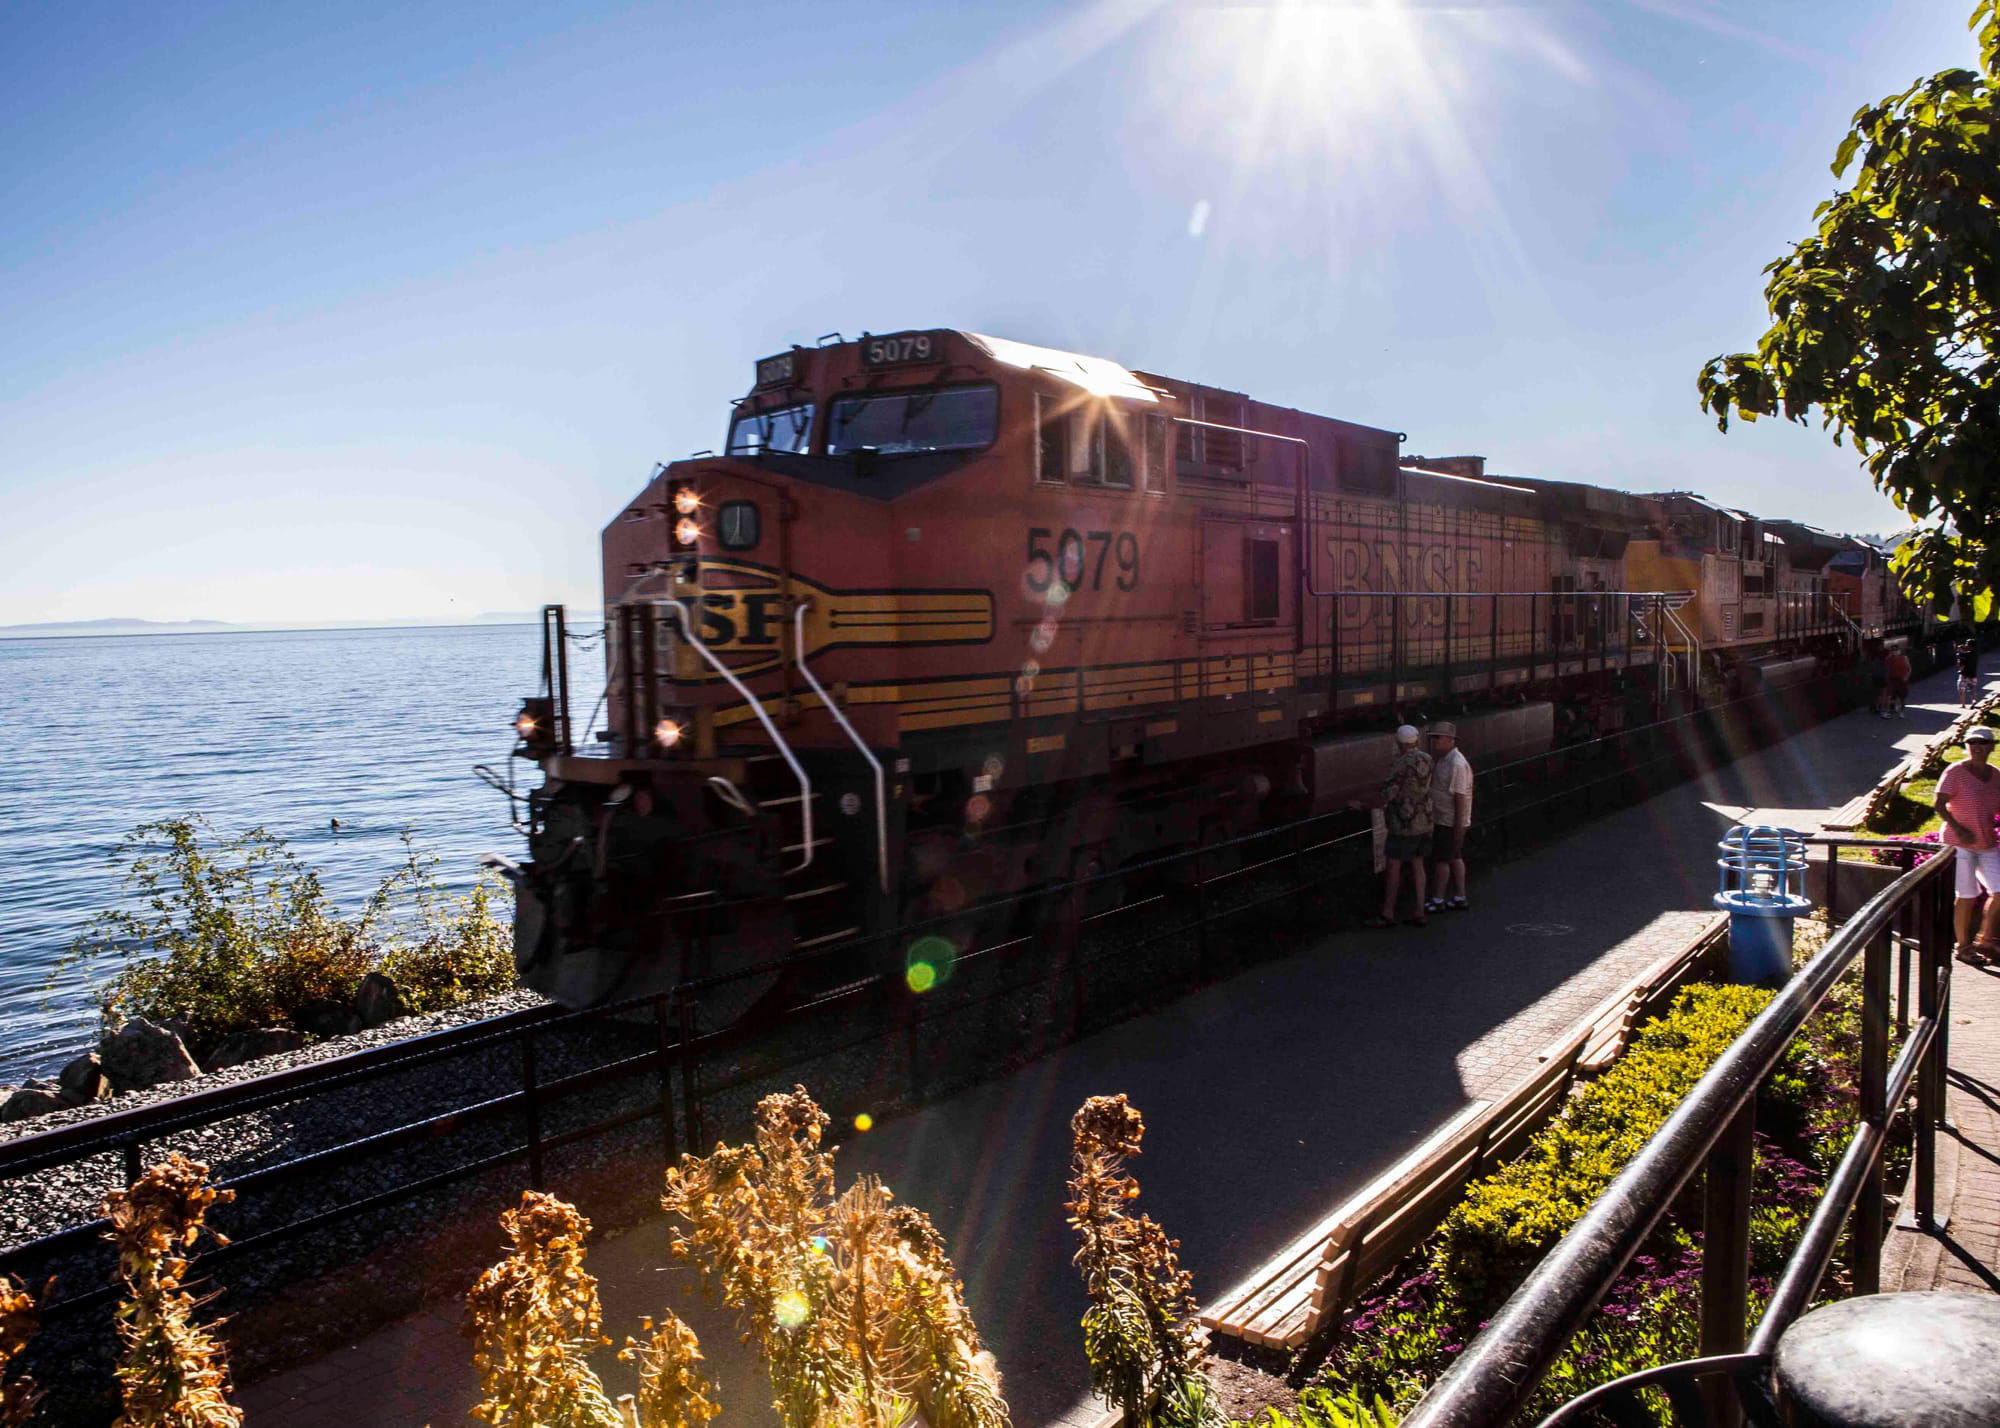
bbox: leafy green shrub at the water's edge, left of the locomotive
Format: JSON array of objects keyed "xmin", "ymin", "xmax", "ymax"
[{"xmin": 68, "ymin": 816, "xmax": 514, "ymax": 1058}]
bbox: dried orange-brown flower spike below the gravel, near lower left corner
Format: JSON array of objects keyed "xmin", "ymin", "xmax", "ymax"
[{"xmin": 102, "ymin": 1152, "xmax": 244, "ymax": 1428}]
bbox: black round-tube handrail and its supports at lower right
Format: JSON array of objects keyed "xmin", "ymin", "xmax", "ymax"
[{"xmin": 1404, "ymin": 850, "xmax": 1950, "ymax": 1428}]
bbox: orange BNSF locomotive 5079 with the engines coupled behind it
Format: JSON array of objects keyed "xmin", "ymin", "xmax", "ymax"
[{"xmin": 492, "ymin": 330, "xmax": 1912, "ymax": 1016}]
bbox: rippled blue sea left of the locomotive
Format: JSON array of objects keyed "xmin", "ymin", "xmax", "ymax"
[{"xmin": 0, "ymin": 624, "xmax": 564, "ymax": 1082}]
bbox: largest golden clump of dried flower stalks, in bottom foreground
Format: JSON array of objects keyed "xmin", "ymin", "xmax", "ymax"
[{"xmin": 660, "ymin": 1086, "xmax": 1008, "ymax": 1428}]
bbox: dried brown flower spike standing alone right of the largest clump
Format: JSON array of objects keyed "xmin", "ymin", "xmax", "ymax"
[{"xmin": 1066, "ymin": 1096, "xmax": 1222, "ymax": 1428}]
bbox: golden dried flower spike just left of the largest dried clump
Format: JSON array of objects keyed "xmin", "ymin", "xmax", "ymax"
[{"xmin": 464, "ymin": 1190, "xmax": 622, "ymax": 1428}]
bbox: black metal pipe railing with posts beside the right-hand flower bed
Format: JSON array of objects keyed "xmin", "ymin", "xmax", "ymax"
[{"xmin": 1404, "ymin": 838, "xmax": 1952, "ymax": 1428}]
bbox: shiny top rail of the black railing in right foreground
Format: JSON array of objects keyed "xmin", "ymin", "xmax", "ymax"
[{"xmin": 1404, "ymin": 844, "xmax": 1946, "ymax": 1428}]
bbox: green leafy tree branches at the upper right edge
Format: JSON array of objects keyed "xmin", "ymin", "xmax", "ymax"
[{"xmin": 1700, "ymin": 0, "xmax": 2000, "ymax": 620}]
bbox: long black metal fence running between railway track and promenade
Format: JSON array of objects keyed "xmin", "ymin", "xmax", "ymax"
[{"xmin": 0, "ymin": 674, "xmax": 1920, "ymax": 1400}]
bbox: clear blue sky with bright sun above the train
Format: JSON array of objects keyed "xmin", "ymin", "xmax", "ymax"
[{"xmin": 0, "ymin": 0, "xmax": 1976, "ymax": 624}]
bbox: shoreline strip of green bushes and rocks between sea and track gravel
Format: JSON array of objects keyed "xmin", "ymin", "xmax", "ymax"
[{"xmin": 0, "ymin": 816, "xmax": 514, "ymax": 1120}]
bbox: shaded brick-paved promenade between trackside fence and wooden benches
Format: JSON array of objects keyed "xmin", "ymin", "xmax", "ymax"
[{"xmin": 234, "ymin": 672, "xmax": 2000, "ymax": 1428}]
